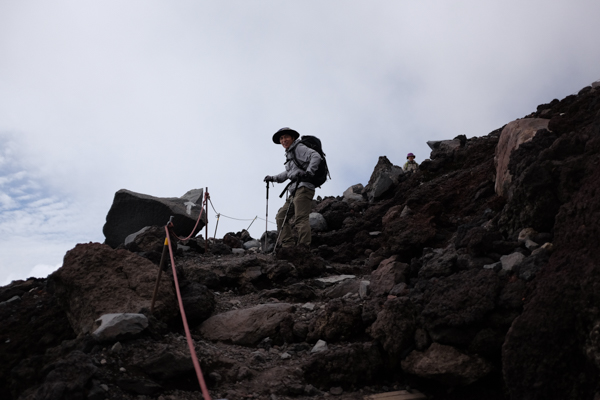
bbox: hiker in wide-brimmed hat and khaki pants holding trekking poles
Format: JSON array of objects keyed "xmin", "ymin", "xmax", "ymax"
[{"xmin": 264, "ymin": 128, "xmax": 322, "ymax": 248}]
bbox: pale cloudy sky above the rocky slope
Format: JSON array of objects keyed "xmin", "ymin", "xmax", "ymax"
[{"xmin": 0, "ymin": 0, "xmax": 600, "ymax": 285}]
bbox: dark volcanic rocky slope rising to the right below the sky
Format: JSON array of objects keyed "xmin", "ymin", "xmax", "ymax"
[{"xmin": 0, "ymin": 82, "xmax": 600, "ymax": 400}]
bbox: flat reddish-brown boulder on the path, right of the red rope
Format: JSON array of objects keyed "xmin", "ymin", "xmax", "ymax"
[{"xmin": 199, "ymin": 303, "xmax": 294, "ymax": 346}]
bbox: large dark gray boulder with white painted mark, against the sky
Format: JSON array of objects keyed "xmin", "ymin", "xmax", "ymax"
[{"xmin": 102, "ymin": 189, "xmax": 207, "ymax": 248}]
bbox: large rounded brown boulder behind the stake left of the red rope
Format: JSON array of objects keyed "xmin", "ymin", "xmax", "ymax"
[{"xmin": 49, "ymin": 243, "xmax": 178, "ymax": 334}]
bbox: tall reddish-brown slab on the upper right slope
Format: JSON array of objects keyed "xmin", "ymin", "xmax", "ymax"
[{"xmin": 494, "ymin": 118, "xmax": 549, "ymax": 197}]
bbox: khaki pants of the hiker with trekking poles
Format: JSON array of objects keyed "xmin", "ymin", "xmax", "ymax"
[{"xmin": 275, "ymin": 186, "xmax": 315, "ymax": 247}]
